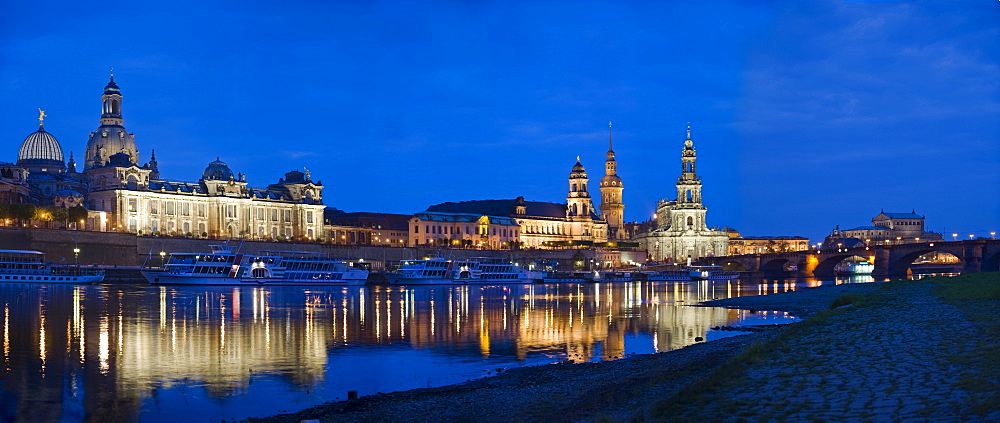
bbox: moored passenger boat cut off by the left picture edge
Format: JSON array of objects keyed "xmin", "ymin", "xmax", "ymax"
[{"xmin": 0, "ymin": 250, "xmax": 104, "ymax": 283}]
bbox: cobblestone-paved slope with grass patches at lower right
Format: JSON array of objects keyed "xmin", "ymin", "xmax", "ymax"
[{"xmin": 651, "ymin": 273, "xmax": 1000, "ymax": 420}]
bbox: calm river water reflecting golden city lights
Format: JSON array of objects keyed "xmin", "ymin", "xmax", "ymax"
[{"xmin": 0, "ymin": 280, "xmax": 864, "ymax": 422}]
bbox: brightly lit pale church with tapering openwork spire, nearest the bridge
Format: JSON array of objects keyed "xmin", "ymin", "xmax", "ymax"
[{"xmin": 639, "ymin": 126, "xmax": 729, "ymax": 263}]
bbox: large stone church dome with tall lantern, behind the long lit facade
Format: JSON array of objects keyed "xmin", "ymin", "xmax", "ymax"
[{"xmin": 83, "ymin": 73, "xmax": 139, "ymax": 171}]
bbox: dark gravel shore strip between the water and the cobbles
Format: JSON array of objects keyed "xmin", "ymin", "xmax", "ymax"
[{"xmin": 251, "ymin": 284, "xmax": 877, "ymax": 422}]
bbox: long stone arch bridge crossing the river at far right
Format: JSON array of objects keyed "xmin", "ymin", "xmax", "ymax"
[{"xmin": 697, "ymin": 239, "xmax": 1000, "ymax": 278}]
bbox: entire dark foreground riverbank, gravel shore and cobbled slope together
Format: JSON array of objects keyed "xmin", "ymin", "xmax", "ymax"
[{"xmin": 252, "ymin": 273, "xmax": 1000, "ymax": 422}]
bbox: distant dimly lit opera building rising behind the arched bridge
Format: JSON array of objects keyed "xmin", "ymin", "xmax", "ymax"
[{"xmin": 823, "ymin": 210, "xmax": 944, "ymax": 248}]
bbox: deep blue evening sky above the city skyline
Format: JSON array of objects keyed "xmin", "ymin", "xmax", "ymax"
[{"xmin": 0, "ymin": 0, "xmax": 1000, "ymax": 239}]
